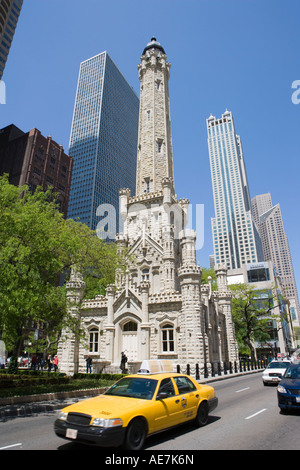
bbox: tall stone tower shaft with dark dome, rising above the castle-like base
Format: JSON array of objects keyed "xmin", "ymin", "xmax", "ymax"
[{"xmin": 136, "ymin": 37, "xmax": 175, "ymax": 196}]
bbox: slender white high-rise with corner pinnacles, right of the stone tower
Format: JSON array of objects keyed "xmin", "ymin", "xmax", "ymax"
[{"xmin": 207, "ymin": 110, "xmax": 263, "ymax": 269}]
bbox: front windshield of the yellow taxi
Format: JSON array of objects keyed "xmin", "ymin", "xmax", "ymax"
[{"xmin": 105, "ymin": 377, "xmax": 157, "ymax": 400}]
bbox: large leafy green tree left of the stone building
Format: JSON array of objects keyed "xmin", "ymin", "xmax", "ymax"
[{"xmin": 0, "ymin": 176, "xmax": 117, "ymax": 355}]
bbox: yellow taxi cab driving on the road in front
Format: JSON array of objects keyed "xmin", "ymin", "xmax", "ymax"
[{"xmin": 54, "ymin": 361, "xmax": 218, "ymax": 450}]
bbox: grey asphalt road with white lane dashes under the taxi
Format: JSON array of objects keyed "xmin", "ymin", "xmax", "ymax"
[{"xmin": 0, "ymin": 373, "xmax": 300, "ymax": 452}]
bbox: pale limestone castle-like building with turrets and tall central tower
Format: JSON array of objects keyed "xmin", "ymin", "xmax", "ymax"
[{"xmin": 58, "ymin": 38, "xmax": 238, "ymax": 374}]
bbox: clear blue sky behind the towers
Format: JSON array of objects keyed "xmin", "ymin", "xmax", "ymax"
[{"xmin": 0, "ymin": 0, "xmax": 300, "ymax": 289}]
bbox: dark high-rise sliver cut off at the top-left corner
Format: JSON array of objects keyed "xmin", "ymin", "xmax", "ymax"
[{"xmin": 0, "ymin": 0, "xmax": 23, "ymax": 80}]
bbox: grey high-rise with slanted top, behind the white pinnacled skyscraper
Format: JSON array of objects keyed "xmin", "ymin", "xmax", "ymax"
[{"xmin": 251, "ymin": 193, "xmax": 300, "ymax": 321}]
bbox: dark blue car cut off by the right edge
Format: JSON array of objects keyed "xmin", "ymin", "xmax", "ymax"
[{"xmin": 277, "ymin": 362, "xmax": 300, "ymax": 411}]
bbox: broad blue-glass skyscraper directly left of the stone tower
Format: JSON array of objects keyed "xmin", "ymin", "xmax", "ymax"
[{"xmin": 68, "ymin": 51, "xmax": 139, "ymax": 234}]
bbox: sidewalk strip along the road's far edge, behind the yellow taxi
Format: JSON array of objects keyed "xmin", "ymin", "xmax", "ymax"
[{"xmin": 0, "ymin": 369, "xmax": 264, "ymax": 421}]
